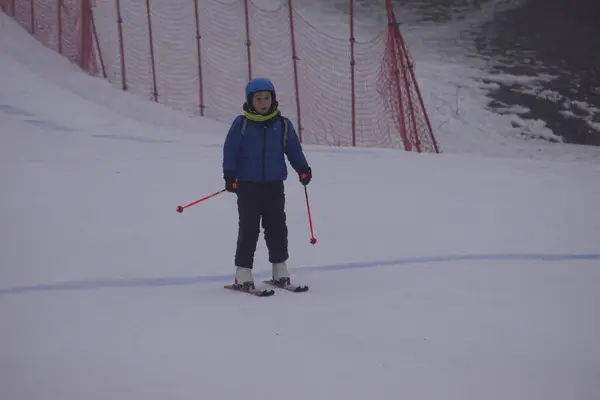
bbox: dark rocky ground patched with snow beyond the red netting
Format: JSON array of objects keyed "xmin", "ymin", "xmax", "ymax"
[{"xmin": 370, "ymin": 0, "xmax": 600, "ymax": 146}]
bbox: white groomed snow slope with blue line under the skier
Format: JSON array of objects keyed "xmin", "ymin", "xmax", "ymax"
[{"xmin": 0, "ymin": 9, "xmax": 600, "ymax": 400}]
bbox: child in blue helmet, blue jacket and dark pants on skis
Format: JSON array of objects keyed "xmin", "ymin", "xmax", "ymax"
[{"xmin": 223, "ymin": 78, "xmax": 312, "ymax": 290}]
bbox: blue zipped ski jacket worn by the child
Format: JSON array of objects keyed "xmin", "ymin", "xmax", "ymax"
[{"xmin": 223, "ymin": 113, "xmax": 308, "ymax": 182}]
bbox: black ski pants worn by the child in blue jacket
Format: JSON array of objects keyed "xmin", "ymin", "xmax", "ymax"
[{"xmin": 235, "ymin": 181, "xmax": 288, "ymax": 268}]
